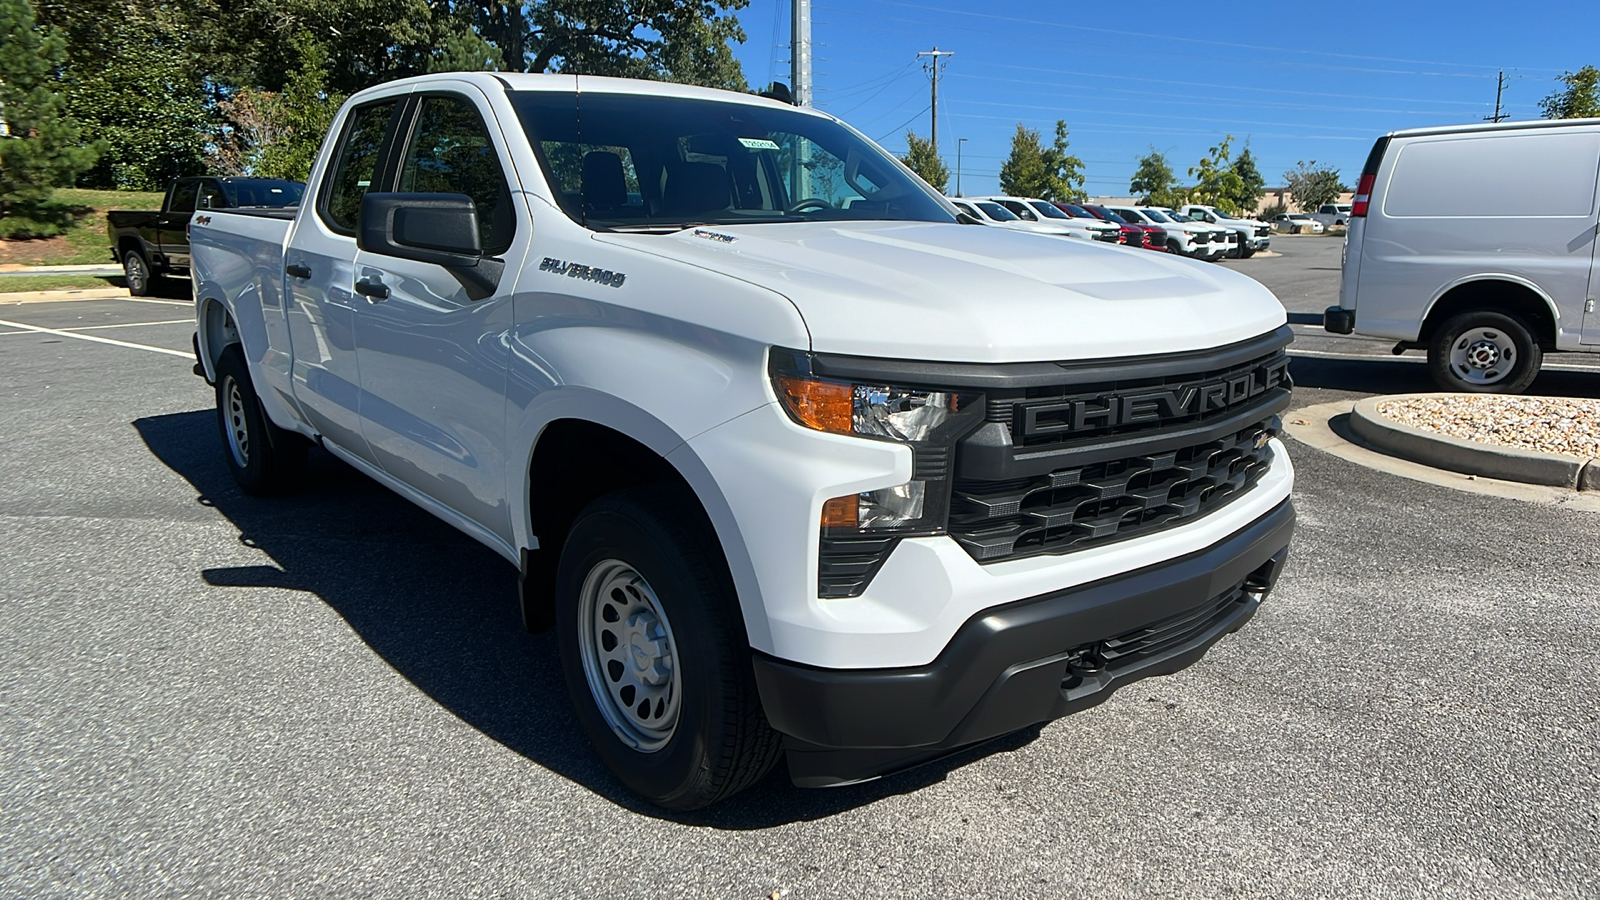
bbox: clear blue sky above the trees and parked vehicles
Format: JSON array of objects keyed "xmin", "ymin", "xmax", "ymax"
[{"xmin": 734, "ymin": 0, "xmax": 1600, "ymax": 195}]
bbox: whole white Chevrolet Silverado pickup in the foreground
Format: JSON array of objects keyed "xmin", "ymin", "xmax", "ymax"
[{"xmin": 192, "ymin": 74, "xmax": 1293, "ymax": 809}]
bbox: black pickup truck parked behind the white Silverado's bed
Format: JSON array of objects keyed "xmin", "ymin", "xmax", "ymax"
[{"xmin": 106, "ymin": 176, "xmax": 306, "ymax": 296}]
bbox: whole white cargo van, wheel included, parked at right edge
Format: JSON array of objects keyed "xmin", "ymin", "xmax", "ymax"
[{"xmin": 1323, "ymin": 119, "xmax": 1600, "ymax": 394}]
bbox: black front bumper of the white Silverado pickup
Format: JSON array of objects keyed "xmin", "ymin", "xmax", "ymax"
[{"xmin": 755, "ymin": 500, "xmax": 1294, "ymax": 786}]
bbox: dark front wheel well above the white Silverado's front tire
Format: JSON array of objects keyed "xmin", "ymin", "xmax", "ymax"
[{"xmin": 520, "ymin": 420, "xmax": 712, "ymax": 631}]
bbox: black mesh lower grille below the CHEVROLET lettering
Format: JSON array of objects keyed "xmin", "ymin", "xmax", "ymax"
[{"xmin": 950, "ymin": 416, "xmax": 1278, "ymax": 562}]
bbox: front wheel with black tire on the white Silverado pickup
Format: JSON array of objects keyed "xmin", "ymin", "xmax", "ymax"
[{"xmin": 555, "ymin": 485, "xmax": 781, "ymax": 810}]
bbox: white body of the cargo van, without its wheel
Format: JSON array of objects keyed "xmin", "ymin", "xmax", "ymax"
[{"xmin": 1341, "ymin": 125, "xmax": 1600, "ymax": 349}]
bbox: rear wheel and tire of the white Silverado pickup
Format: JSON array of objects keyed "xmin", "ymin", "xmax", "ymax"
[{"xmin": 216, "ymin": 344, "xmax": 306, "ymax": 496}]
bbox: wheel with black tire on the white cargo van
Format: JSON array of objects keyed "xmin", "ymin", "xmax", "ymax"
[{"xmin": 1427, "ymin": 311, "xmax": 1544, "ymax": 394}]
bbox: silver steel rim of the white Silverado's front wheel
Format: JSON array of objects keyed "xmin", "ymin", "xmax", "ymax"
[{"xmin": 578, "ymin": 559, "xmax": 683, "ymax": 753}]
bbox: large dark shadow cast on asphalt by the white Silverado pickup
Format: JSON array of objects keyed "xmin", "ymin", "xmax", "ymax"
[{"xmin": 133, "ymin": 410, "xmax": 1038, "ymax": 830}]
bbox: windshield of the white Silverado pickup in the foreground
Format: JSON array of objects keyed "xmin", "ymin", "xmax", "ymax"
[{"xmin": 510, "ymin": 91, "xmax": 955, "ymax": 231}]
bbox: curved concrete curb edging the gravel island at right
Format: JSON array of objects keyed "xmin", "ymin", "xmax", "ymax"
[{"xmin": 1350, "ymin": 394, "xmax": 1600, "ymax": 490}]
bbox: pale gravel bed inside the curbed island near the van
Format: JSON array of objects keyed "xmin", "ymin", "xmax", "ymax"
[{"xmin": 1378, "ymin": 394, "xmax": 1600, "ymax": 460}]
